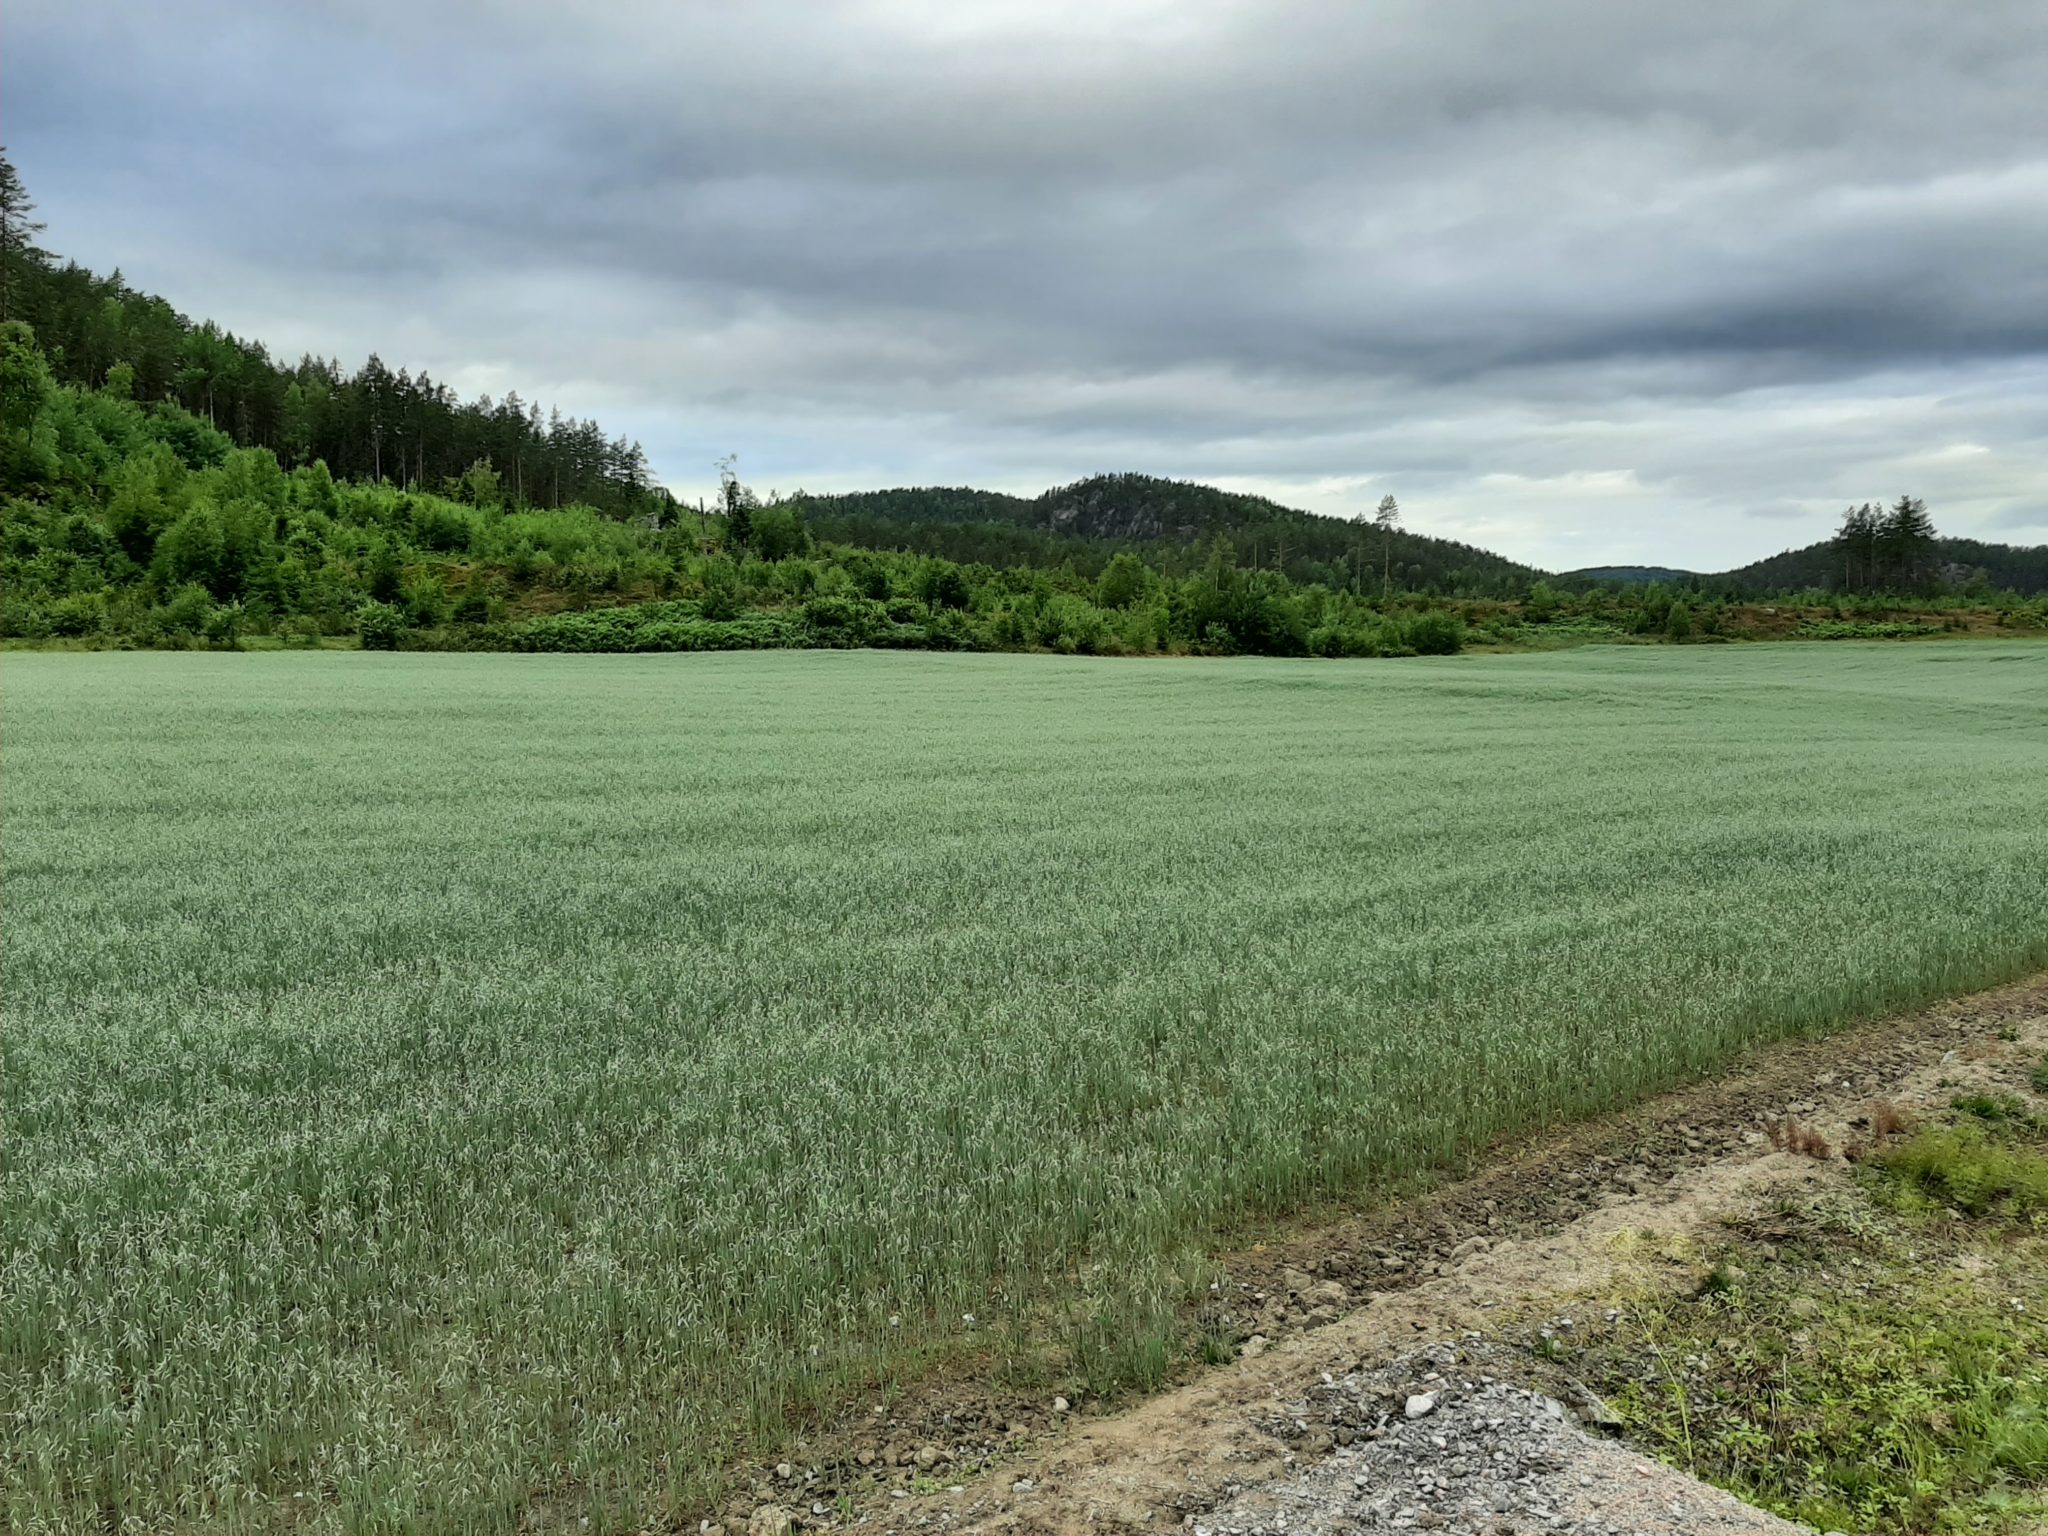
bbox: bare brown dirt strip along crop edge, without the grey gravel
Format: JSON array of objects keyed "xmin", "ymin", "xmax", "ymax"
[{"xmin": 727, "ymin": 977, "xmax": 2048, "ymax": 1536}]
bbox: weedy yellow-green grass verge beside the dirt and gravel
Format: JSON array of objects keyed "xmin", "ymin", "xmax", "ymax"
[{"xmin": 1546, "ymin": 1073, "xmax": 2048, "ymax": 1536}]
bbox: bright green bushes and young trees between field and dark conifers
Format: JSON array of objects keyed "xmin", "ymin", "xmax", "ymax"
[{"xmin": 0, "ymin": 322, "xmax": 1490, "ymax": 655}]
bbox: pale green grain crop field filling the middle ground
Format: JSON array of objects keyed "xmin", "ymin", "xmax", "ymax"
[{"xmin": 12, "ymin": 641, "xmax": 2048, "ymax": 1532}]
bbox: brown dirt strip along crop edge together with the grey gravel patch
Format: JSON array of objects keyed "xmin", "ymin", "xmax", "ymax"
[{"xmin": 705, "ymin": 977, "xmax": 2048, "ymax": 1536}]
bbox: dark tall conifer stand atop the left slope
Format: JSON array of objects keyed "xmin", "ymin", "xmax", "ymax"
[{"xmin": 0, "ymin": 154, "xmax": 668, "ymax": 518}]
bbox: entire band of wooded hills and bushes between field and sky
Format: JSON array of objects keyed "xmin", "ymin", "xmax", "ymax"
[{"xmin": 0, "ymin": 158, "xmax": 2048, "ymax": 655}]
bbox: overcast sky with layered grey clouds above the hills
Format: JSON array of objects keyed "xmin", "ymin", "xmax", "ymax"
[{"xmin": 16, "ymin": 0, "xmax": 2048, "ymax": 567}]
